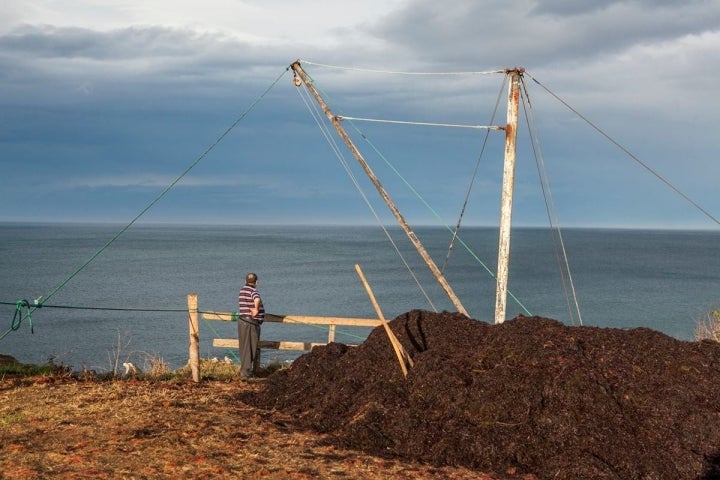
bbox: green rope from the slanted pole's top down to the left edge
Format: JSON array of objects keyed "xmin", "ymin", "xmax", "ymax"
[{"xmin": 0, "ymin": 67, "xmax": 289, "ymax": 340}]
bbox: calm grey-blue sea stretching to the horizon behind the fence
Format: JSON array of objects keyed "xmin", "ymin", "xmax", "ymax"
[{"xmin": 0, "ymin": 224, "xmax": 720, "ymax": 371}]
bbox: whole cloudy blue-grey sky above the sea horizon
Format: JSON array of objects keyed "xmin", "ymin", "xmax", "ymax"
[{"xmin": 0, "ymin": 0, "xmax": 720, "ymax": 230}]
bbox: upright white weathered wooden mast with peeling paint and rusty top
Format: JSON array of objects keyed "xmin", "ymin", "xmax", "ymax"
[{"xmin": 495, "ymin": 68, "xmax": 525, "ymax": 323}]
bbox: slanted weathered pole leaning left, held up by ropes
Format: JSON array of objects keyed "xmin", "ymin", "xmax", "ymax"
[{"xmin": 290, "ymin": 62, "xmax": 469, "ymax": 316}]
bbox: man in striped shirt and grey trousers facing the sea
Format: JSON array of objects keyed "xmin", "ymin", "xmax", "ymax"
[{"xmin": 238, "ymin": 273, "xmax": 265, "ymax": 378}]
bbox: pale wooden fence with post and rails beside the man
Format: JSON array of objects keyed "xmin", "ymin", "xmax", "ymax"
[{"xmin": 187, "ymin": 293, "xmax": 382, "ymax": 382}]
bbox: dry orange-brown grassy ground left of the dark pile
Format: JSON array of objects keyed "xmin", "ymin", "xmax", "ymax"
[{"xmin": 0, "ymin": 375, "xmax": 496, "ymax": 480}]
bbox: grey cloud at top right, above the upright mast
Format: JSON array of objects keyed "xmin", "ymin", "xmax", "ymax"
[{"xmin": 366, "ymin": 0, "xmax": 720, "ymax": 67}]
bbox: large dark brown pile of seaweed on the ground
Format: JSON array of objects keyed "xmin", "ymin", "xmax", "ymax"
[{"xmin": 243, "ymin": 310, "xmax": 720, "ymax": 479}]
